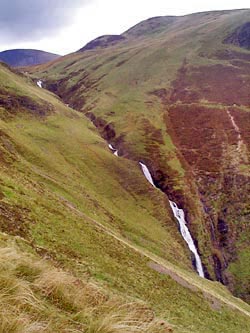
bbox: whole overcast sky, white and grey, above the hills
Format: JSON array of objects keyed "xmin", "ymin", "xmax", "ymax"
[{"xmin": 0, "ymin": 0, "xmax": 250, "ymax": 54}]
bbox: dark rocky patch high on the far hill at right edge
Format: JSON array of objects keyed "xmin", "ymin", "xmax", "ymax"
[{"xmin": 224, "ymin": 22, "xmax": 250, "ymax": 50}]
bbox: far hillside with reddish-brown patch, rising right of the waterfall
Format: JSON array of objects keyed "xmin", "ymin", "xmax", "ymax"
[{"xmin": 26, "ymin": 9, "xmax": 250, "ymax": 301}]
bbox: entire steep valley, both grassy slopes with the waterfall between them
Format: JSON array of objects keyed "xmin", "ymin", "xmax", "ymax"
[{"xmin": 0, "ymin": 9, "xmax": 250, "ymax": 333}]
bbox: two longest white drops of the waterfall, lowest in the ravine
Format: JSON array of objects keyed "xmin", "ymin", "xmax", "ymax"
[{"xmin": 139, "ymin": 162, "xmax": 204, "ymax": 278}]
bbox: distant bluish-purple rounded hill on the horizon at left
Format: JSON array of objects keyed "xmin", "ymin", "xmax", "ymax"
[{"xmin": 0, "ymin": 49, "xmax": 60, "ymax": 67}]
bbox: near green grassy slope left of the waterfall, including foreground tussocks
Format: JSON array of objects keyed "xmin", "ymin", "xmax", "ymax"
[{"xmin": 0, "ymin": 58, "xmax": 249, "ymax": 333}]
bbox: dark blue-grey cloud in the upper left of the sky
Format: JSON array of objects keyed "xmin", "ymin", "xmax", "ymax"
[{"xmin": 0, "ymin": 0, "xmax": 92, "ymax": 42}]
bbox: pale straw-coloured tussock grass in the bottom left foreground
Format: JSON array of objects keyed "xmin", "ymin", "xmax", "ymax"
[{"xmin": 0, "ymin": 240, "xmax": 172, "ymax": 333}]
